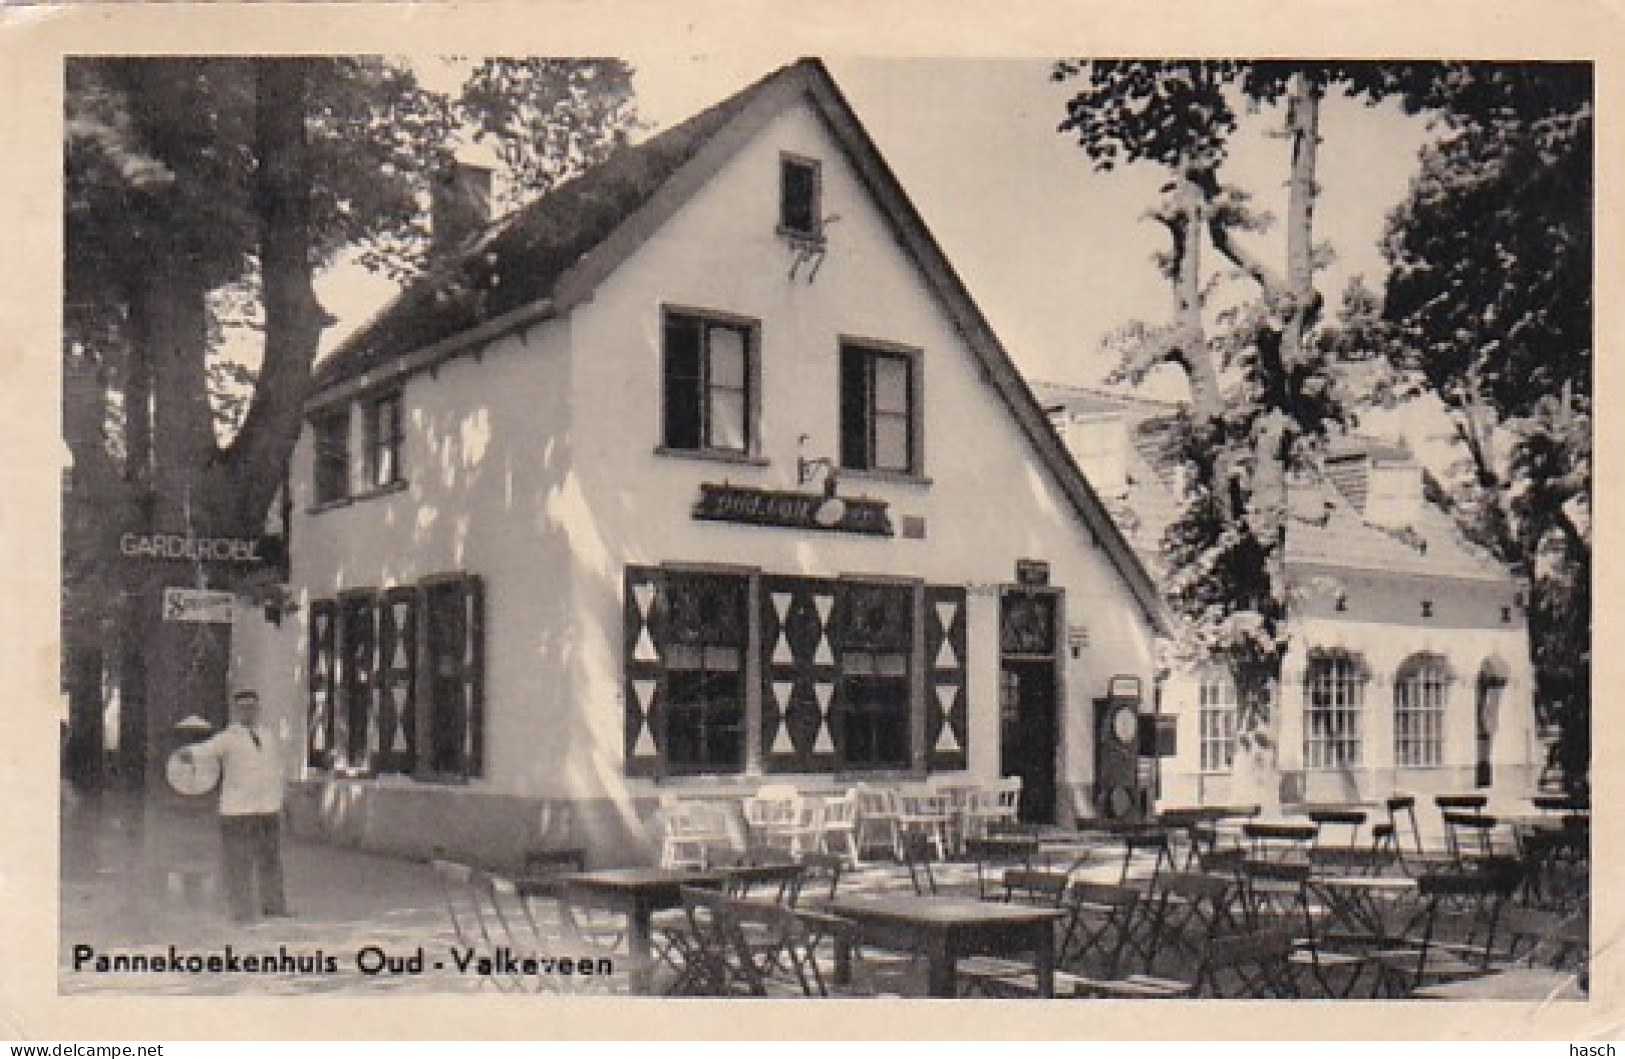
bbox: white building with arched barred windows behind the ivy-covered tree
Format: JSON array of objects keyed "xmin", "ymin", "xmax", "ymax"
[{"xmin": 1035, "ymin": 385, "xmax": 1545, "ymax": 825}]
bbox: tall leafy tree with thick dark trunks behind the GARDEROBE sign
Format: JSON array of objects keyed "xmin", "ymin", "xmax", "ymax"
[{"xmin": 63, "ymin": 58, "xmax": 634, "ymax": 780}]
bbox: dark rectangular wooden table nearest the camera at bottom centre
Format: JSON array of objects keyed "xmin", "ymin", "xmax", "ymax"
[{"xmin": 829, "ymin": 897, "xmax": 1064, "ymax": 997}]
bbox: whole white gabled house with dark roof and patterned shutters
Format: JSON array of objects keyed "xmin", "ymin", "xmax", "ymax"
[{"xmin": 239, "ymin": 60, "xmax": 1162, "ymax": 861}]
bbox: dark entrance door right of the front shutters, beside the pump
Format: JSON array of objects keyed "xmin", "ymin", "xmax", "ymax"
[{"xmin": 999, "ymin": 591, "xmax": 1060, "ymax": 823}]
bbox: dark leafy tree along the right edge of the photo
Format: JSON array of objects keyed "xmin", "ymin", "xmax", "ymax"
[{"xmin": 1362, "ymin": 63, "xmax": 1594, "ymax": 788}]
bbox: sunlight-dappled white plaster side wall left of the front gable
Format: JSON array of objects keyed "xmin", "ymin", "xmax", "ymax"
[{"xmin": 291, "ymin": 322, "xmax": 582, "ymax": 794}]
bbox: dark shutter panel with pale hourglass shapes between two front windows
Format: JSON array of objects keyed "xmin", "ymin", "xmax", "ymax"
[{"xmin": 762, "ymin": 575, "xmax": 840, "ymax": 772}]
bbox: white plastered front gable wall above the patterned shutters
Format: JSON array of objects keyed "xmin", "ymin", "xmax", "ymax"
[{"xmin": 572, "ymin": 101, "xmax": 1151, "ymax": 792}]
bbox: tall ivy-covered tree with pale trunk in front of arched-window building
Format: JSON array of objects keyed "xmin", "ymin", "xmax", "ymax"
[{"xmin": 1055, "ymin": 60, "xmax": 1388, "ymax": 804}]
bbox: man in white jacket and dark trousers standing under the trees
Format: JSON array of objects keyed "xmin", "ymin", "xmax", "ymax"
[{"xmin": 180, "ymin": 690, "xmax": 288, "ymax": 923}]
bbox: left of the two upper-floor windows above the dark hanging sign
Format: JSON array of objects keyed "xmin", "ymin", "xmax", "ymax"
[{"xmin": 661, "ymin": 309, "xmax": 759, "ymax": 460}]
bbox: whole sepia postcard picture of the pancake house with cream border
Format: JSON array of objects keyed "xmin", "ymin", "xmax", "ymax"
[{"xmin": 0, "ymin": 3, "xmax": 1619, "ymax": 1040}]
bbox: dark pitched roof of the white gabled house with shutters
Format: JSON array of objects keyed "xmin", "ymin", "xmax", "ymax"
[{"xmin": 307, "ymin": 58, "xmax": 1170, "ymax": 632}]
